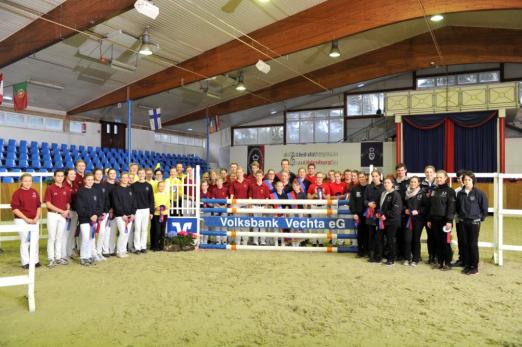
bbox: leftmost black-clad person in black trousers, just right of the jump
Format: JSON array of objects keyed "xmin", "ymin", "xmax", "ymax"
[{"xmin": 347, "ymin": 171, "xmax": 369, "ymax": 257}]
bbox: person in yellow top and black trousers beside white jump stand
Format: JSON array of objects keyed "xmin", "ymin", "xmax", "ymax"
[{"xmin": 150, "ymin": 181, "xmax": 170, "ymax": 252}]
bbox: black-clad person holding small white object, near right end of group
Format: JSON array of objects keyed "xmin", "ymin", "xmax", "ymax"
[{"xmin": 428, "ymin": 170, "xmax": 456, "ymax": 270}]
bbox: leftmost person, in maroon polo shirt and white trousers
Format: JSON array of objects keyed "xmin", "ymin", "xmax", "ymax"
[{"xmin": 11, "ymin": 173, "xmax": 41, "ymax": 269}]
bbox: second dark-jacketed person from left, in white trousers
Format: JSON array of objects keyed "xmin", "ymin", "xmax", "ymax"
[{"xmin": 92, "ymin": 168, "xmax": 111, "ymax": 261}]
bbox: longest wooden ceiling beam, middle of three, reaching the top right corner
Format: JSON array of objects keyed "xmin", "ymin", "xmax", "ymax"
[{"xmin": 68, "ymin": 0, "xmax": 522, "ymax": 114}]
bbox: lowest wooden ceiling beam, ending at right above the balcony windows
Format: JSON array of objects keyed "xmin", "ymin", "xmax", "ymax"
[{"xmin": 164, "ymin": 27, "xmax": 522, "ymax": 126}]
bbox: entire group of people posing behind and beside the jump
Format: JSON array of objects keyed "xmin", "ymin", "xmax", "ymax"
[{"xmin": 11, "ymin": 159, "xmax": 488, "ymax": 274}]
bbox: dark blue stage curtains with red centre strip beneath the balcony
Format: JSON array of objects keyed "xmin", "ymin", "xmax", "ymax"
[{"xmin": 402, "ymin": 111, "xmax": 498, "ymax": 172}]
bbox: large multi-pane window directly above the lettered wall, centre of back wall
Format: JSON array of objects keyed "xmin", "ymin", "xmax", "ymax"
[{"xmin": 286, "ymin": 107, "xmax": 342, "ymax": 143}]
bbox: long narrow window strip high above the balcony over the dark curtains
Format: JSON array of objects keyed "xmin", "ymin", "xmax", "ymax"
[{"xmin": 417, "ymin": 71, "xmax": 500, "ymax": 89}]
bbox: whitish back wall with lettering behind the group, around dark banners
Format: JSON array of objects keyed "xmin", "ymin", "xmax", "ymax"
[{"xmin": 230, "ymin": 142, "xmax": 395, "ymax": 172}]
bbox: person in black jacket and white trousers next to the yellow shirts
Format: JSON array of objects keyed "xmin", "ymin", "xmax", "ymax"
[{"xmin": 131, "ymin": 168, "xmax": 154, "ymax": 253}]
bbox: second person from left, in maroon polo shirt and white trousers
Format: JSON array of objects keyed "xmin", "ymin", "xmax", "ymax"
[{"xmin": 44, "ymin": 170, "xmax": 71, "ymax": 267}]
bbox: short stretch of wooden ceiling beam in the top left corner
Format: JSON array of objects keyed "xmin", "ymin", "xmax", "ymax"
[{"xmin": 0, "ymin": 0, "xmax": 135, "ymax": 68}]
